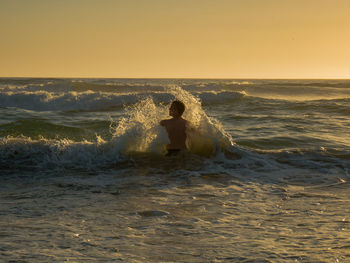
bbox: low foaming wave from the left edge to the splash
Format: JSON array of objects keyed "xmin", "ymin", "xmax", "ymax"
[{"xmin": 0, "ymin": 137, "xmax": 123, "ymax": 172}]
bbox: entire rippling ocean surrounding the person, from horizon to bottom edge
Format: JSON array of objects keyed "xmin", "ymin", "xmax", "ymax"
[{"xmin": 0, "ymin": 78, "xmax": 350, "ymax": 262}]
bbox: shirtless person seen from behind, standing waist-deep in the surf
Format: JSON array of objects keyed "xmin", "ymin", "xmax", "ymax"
[{"xmin": 160, "ymin": 100, "xmax": 188, "ymax": 156}]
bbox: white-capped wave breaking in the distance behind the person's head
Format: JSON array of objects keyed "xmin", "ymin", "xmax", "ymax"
[{"xmin": 0, "ymin": 88, "xmax": 246, "ymax": 111}]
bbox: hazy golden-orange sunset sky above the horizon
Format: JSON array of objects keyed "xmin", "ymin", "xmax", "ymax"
[{"xmin": 0, "ymin": 0, "xmax": 350, "ymax": 78}]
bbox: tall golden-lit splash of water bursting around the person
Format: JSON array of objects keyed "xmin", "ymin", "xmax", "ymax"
[{"xmin": 112, "ymin": 86, "xmax": 233, "ymax": 156}]
